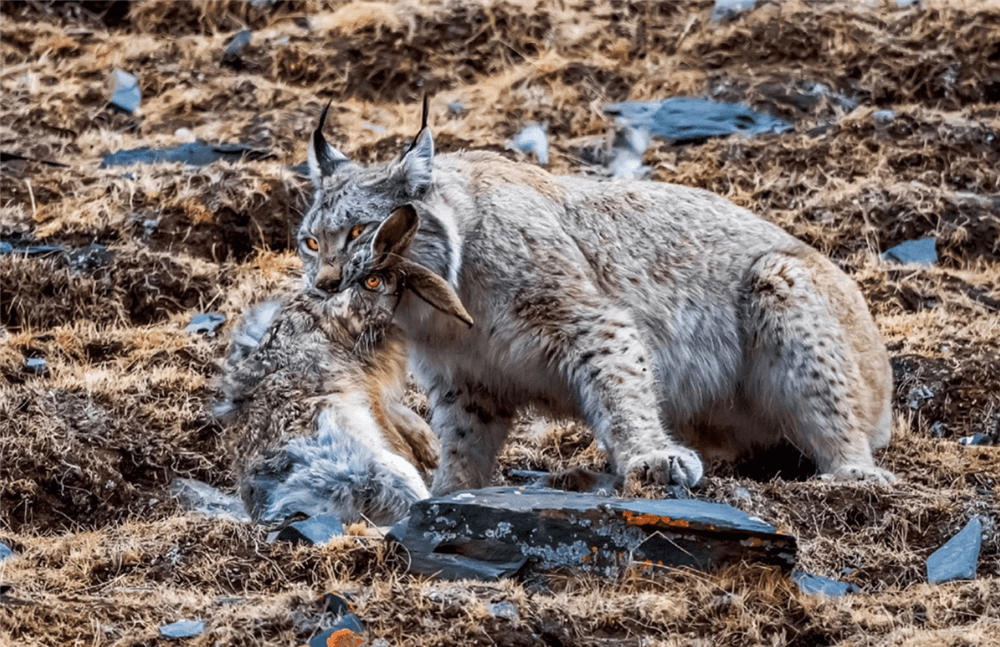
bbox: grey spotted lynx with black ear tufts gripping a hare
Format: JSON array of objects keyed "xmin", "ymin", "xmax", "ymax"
[{"xmin": 299, "ymin": 104, "xmax": 893, "ymax": 494}]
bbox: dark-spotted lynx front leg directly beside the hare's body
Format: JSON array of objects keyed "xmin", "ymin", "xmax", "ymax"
[{"xmin": 428, "ymin": 378, "xmax": 513, "ymax": 496}]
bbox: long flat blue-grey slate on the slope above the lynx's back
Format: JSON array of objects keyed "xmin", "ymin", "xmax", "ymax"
[{"xmin": 604, "ymin": 97, "xmax": 793, "ymax": 143}]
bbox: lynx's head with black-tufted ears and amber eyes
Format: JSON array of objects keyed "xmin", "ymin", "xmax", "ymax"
[{"xmin": 299, "ymin": 100, "xmax": 457, "ymax": 293}]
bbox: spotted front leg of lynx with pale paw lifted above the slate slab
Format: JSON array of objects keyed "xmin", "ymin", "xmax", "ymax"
[{"xmin": 562, "ymin": 307, "xmax": 704, "ymax": 487}]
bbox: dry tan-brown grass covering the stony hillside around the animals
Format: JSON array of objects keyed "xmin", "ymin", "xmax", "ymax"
[{"xmin": 0, "ymin": 0, "xmax": 1000, "ymax": 647}]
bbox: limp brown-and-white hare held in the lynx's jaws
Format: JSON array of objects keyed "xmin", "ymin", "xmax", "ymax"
[{"xmin": 216, "ymin": 206, "xmax": 471, "ymax": 524}]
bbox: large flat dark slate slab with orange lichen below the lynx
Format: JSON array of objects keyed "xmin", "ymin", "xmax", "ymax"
[{"xmin": 388, "ymin": 487, "xmax": 796, "ymax": 580}]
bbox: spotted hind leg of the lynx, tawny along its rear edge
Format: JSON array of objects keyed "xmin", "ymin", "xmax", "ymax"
[{"xmin": 743, "ymin": 249, "xmax": 895, "ymax": 483}]
